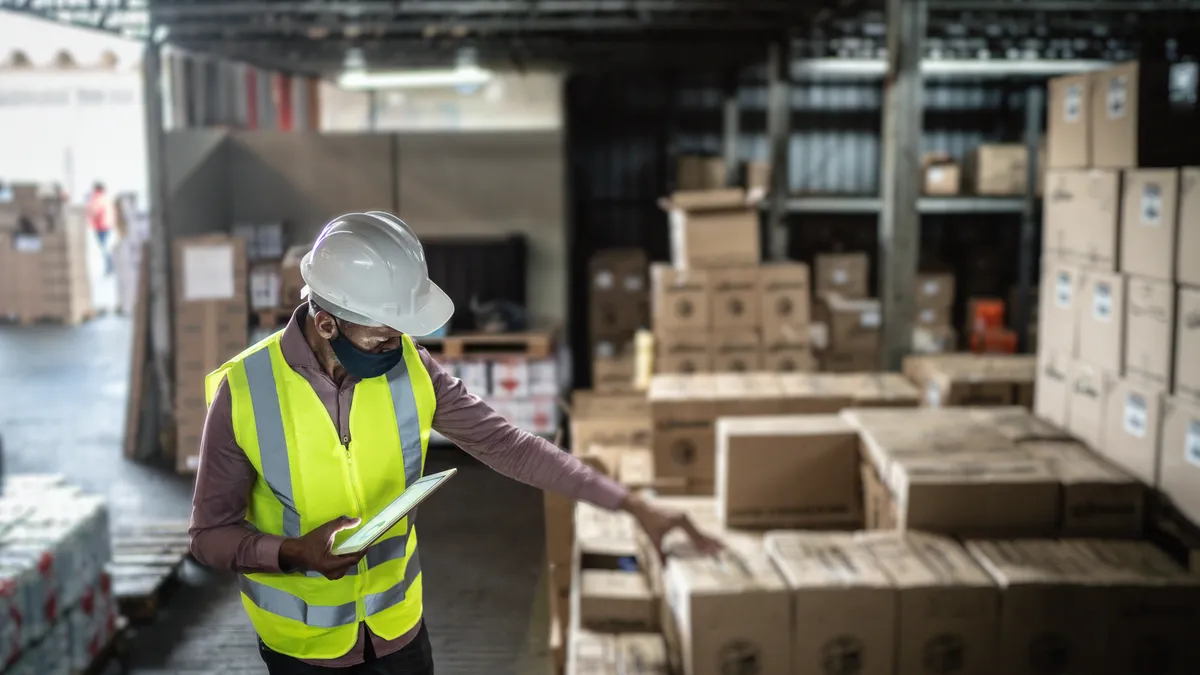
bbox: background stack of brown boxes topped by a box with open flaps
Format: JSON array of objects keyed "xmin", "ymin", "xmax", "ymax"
[{"xmin": 650, "ymin": 190, "xmax": 811, "ymax": 372}]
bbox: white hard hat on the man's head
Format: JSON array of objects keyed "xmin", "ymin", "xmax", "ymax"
[{"xmin": 300, "ymin": 211, "xmax": 454, "ymax": 336}]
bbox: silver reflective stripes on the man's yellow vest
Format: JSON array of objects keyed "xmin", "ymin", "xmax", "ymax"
[{"xmin": 241, "ymin": 346, "xmax": 421, "ymax": 600}]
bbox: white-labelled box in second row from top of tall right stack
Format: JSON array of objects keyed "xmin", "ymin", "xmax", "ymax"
[{"xmin": 1121, "ymin": 169, "xmax": 1180, "ymax": 281}]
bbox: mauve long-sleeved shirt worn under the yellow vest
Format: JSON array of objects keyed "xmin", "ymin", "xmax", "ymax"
[{"xmin": 188, "ymin": 305, "xmax": 628, "ymax": 668}]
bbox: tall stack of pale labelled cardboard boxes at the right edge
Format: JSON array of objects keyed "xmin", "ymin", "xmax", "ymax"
[{"xmin": 1037, "ymin": 64, "xmax": 1200, "ymax": 522}]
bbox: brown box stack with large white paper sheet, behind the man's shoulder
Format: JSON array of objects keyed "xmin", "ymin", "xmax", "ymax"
[{"xmin": 168, "ymin": 234, "xmax": 248, "ymax": 473}]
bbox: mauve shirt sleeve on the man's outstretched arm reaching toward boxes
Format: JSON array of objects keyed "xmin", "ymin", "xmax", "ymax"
[{"xmin": 420, "ymin": 350, "xmax": 629, "ymax": 510}]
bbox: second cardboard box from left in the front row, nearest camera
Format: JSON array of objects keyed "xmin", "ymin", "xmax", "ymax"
[{"xmin": 764, "ymin": 532, "xmax": 898, "ymax": 675}]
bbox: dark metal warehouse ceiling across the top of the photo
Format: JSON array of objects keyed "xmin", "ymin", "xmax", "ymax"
[{"xmin": 0, "ymin": 0, "xmax": 1200, "ymax": 74}]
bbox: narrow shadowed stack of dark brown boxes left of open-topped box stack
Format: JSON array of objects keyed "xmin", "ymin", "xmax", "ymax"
[{"xmin": 588, "ymin": 249, "xmax": 650, "ymax": 392}]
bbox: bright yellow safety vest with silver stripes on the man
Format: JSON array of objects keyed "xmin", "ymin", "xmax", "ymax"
[{"xmin": 205, "ymin": 331, "xmax": 437, "ymax": 659}]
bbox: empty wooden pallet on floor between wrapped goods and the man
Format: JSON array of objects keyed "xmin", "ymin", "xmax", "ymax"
[{"xmin": 108, "ymin": 521, "xmax": 191, "ymax": 621}]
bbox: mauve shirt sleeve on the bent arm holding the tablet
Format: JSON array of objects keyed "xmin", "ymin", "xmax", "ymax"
[{"xmin": 187, "ymin": 374, "xmax": 283, "ymax": 573}]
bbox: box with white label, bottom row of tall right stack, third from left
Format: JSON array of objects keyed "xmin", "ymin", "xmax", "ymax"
[{"xmin": 1099, "ymin": 380, "xmax": 1164, "ymax": 485}]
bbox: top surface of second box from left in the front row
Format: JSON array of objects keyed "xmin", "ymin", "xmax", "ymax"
[{"xmin": 763, "ymin": 532, "xmax": 892, "ymax": 589}]
